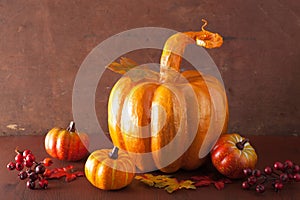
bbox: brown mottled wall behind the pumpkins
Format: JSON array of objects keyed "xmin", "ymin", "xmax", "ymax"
[{"xmin": 0, "ymin": 0, "xmax": 300, "ymax": 135}]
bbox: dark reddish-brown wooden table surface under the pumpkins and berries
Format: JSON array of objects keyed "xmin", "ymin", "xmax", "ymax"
[{"xmin": 0, "ymin": 136, "xmax": 300, "ymax": 200}]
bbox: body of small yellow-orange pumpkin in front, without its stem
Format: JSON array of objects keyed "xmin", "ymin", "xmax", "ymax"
[{"xmin": 84, "ymin": 149, "xmax": 135, "ymax": 190}]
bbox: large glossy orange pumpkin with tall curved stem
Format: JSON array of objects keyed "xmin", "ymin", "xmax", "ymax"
[{"xmin": 108, "ymin": 21, "xmax": 228, "ymax": 173}]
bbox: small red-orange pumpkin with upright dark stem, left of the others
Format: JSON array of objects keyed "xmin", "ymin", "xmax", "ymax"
[{"xmin": 45, "ymin": 122, "xmax": 89, "ymax": 161}]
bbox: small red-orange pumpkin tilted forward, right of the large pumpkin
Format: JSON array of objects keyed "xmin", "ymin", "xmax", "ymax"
[{"xmin": 211, "ymin": 133, "xmax": 257, "ymax": 179}]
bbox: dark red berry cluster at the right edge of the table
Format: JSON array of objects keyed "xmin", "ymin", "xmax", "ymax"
[{"xmin": 242, "ymin": 160, "xmax": 300, "ymax": 193}]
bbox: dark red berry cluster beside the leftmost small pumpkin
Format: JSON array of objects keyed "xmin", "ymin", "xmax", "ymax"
[{"xmin": 7, "ymin": 149, "xmax": 52, "ymax": 189}]
